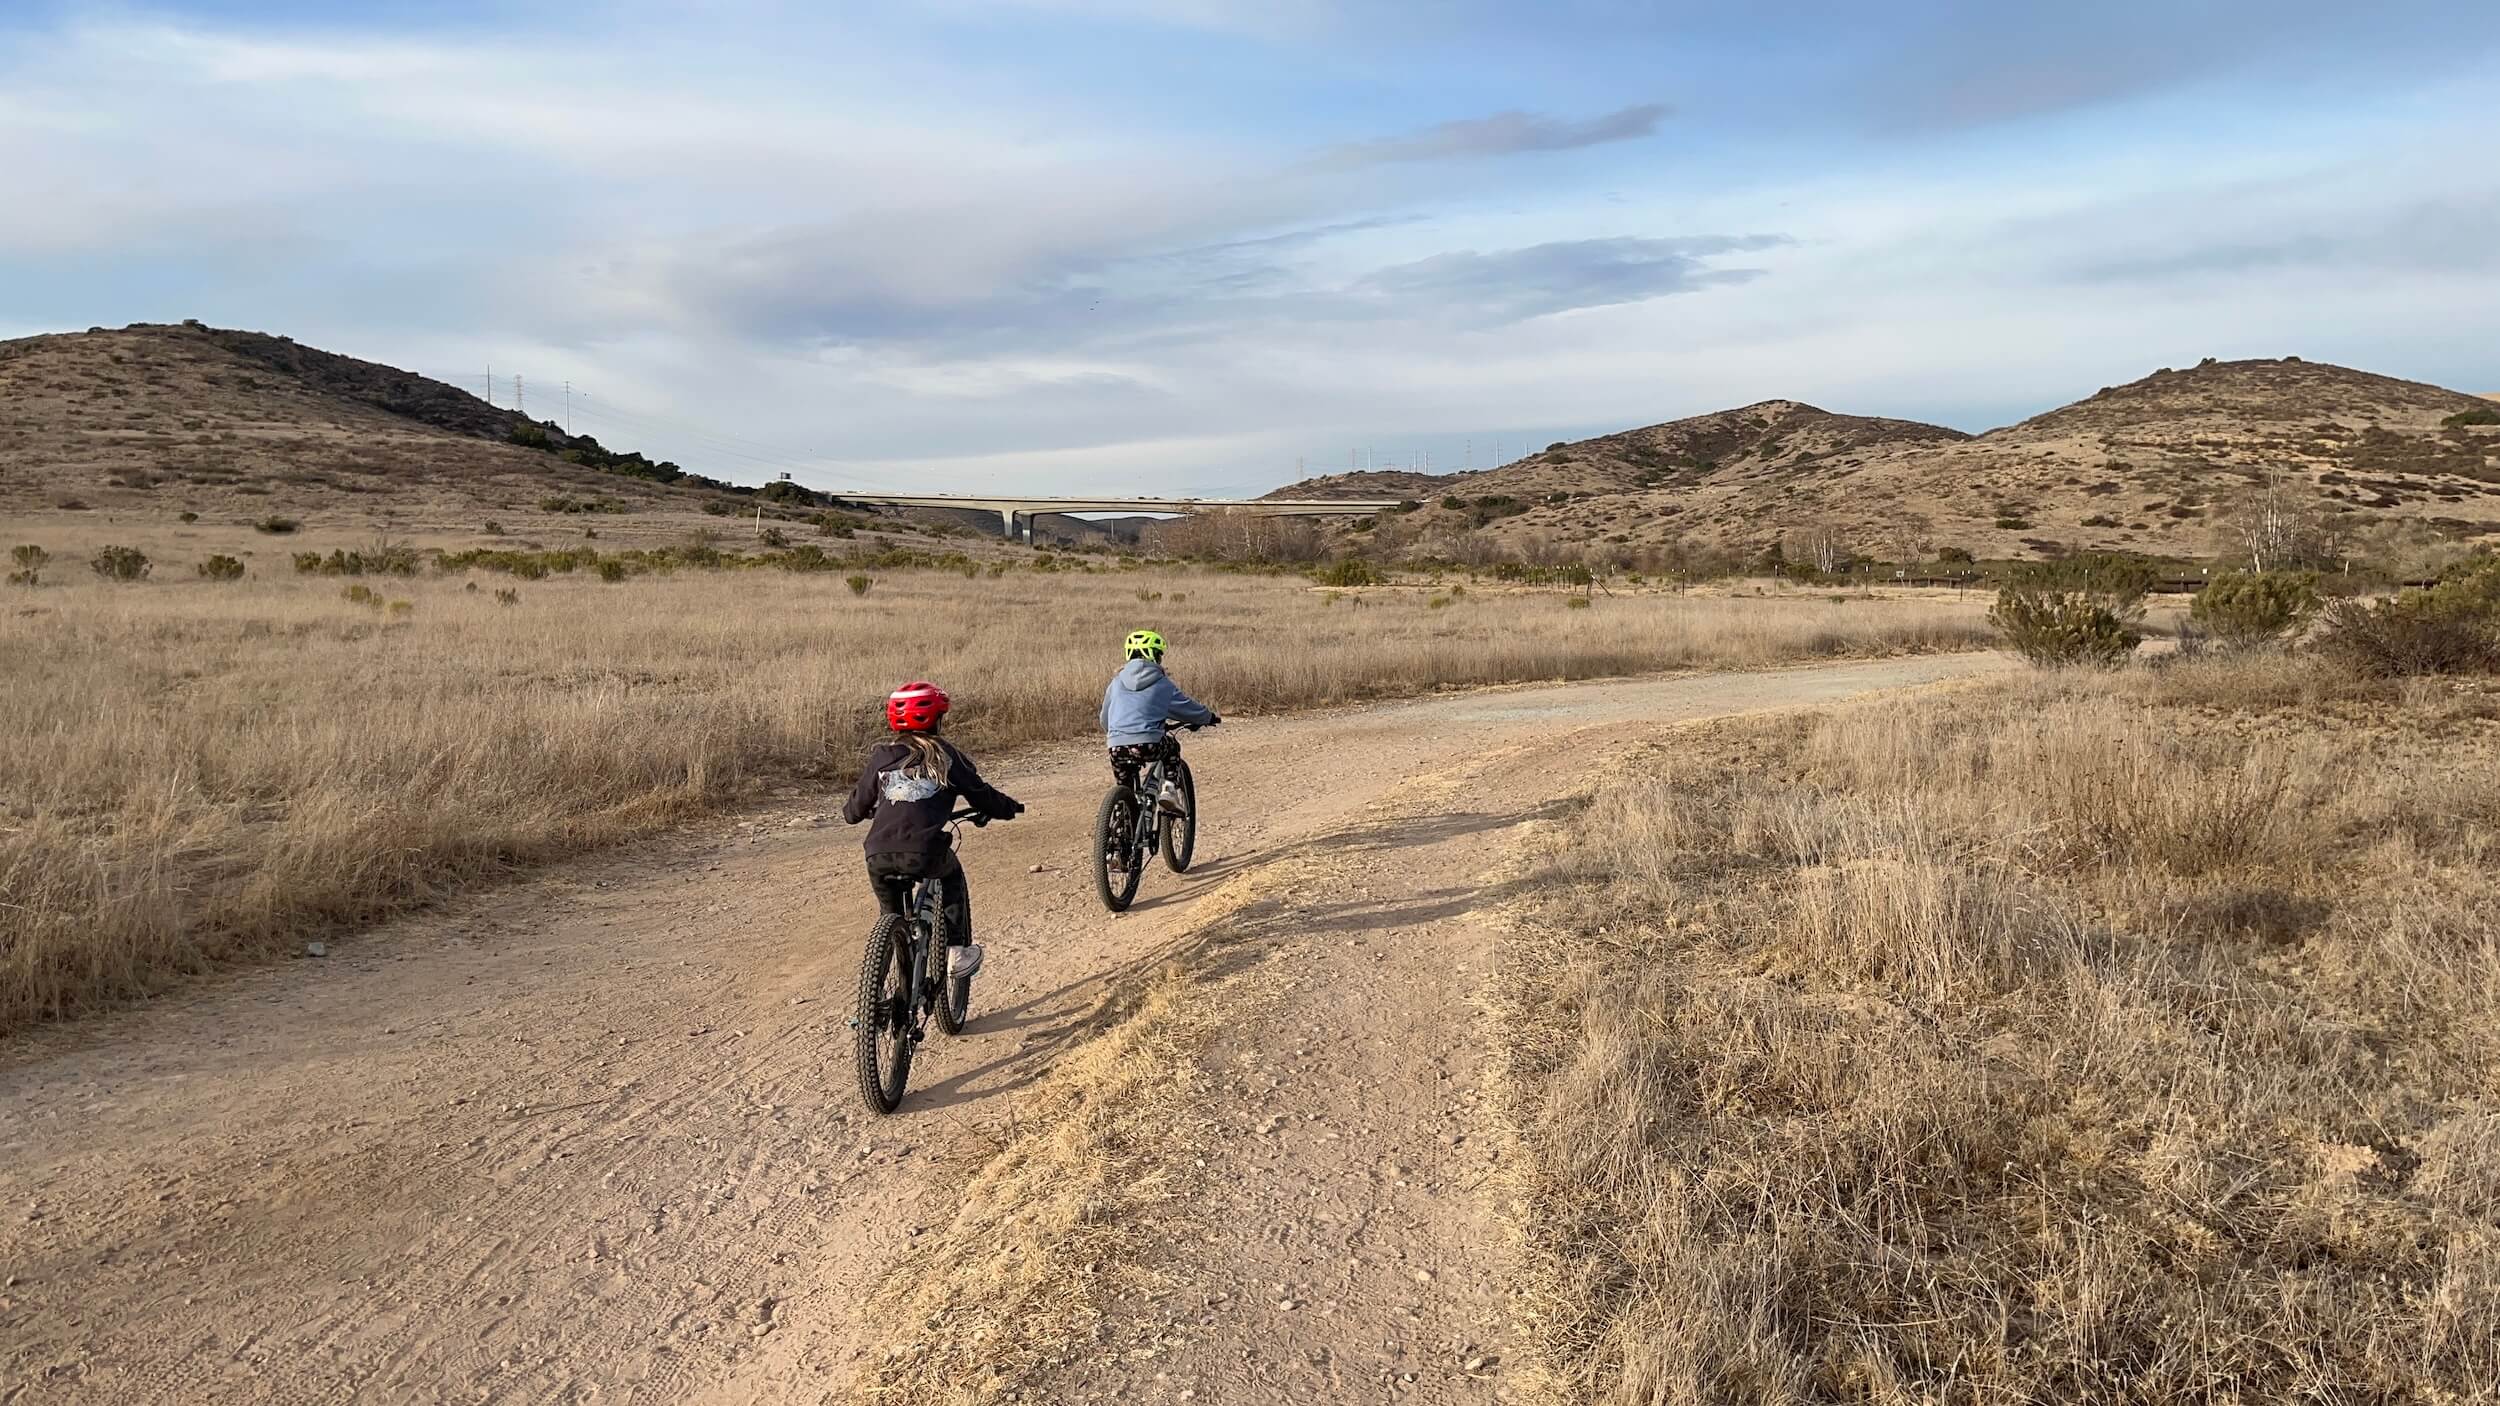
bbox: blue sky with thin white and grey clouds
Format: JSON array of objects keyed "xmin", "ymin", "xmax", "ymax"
[{"xmin": 0, "ymin": 0, "xmax": 2500, "ymax": 493}]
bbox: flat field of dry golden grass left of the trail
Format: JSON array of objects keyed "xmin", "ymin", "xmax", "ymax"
[{"xmin": 0, "ymin": 557, "xmax": 1985, "ymax": 1028}]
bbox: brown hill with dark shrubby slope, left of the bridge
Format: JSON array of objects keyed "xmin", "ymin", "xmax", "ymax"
[{"xmin": 0, "ymin": 323, "xmax": 930, "ymax": 540}]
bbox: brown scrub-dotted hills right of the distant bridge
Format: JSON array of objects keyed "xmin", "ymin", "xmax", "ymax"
[{"xmin": 1278, "ymin": 358, "xmax": 2500, "ymax": 560}]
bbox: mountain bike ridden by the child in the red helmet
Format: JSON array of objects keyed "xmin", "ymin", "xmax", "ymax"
[{"xmin": 850, "ymin": 811, "xmax": 990, "ymax": 1113}]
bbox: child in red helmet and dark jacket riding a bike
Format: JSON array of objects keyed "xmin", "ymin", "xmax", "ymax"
[{"xmin": 843, "ymin": 683, "xmax": 1025, "ymax": 978}]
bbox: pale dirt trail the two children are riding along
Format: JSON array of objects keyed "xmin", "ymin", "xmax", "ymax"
[{"xmin": 0, "ymin": 655, "xmax": 2000, "ymax": 1403}]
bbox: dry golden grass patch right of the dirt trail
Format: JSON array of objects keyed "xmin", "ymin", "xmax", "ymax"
[{"xmin": 1508, "ymin": 658, "xmax": 2500, "ymax": 1403}]
